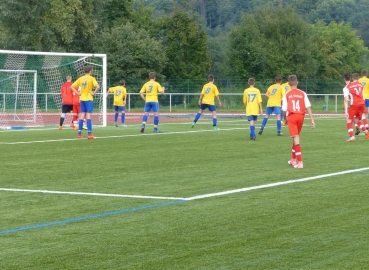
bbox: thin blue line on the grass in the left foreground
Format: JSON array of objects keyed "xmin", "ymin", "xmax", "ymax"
[{"xmin": 0, "ymin": 200, "xmax": 186, "ymax": 235}]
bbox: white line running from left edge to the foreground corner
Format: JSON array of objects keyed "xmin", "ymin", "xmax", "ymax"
[{"xmin": 0, "ymin": 188, "xmax": 184, "ymax": 200}]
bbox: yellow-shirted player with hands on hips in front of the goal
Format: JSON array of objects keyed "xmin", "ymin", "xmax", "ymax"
[{"xmin": 71, "ymin": 66, "xmax": 100, "ymax": 140}]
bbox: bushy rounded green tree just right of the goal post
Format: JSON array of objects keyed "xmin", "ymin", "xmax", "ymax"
[{"xmin": 95, "ymin": 23, "xmax": 167, "ymax": 79}]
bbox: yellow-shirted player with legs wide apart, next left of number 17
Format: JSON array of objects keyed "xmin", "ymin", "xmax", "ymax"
[{"xmin": 191, "ymin": 74, "xmax": 222, "ymax": 130}]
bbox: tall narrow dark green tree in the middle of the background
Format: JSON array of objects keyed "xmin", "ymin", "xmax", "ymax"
[{"xmin": 162, "ymin": 10, "xmax": 211, "ymax": 79}]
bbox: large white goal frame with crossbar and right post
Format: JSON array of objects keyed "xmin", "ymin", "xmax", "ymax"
[{"xmin": 0, "ymin": 50, "xmax": 107, "ymax": 127}]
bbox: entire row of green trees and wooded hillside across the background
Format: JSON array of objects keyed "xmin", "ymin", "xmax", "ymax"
[{"xmin": 0, "ymin": 0, "xmax": 369, "ymax": 82}]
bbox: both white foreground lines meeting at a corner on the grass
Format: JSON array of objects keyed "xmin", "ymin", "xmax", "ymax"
[{"xmin": 0, "ymin": 167, "xmax": 369, "ymax": 201}]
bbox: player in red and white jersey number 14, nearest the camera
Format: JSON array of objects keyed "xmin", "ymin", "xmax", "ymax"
[{"xmin": 282, "ymin": 75, "xmax": 315, "ymax": 169}]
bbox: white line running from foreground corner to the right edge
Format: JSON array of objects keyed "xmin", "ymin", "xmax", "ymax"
[{"xmin": 185, "ymin": 167, "xmax": 369, "ymax": 201}]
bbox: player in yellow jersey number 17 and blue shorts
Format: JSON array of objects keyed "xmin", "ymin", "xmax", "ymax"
[{"xmin": 243, "ymin": 78, "xmax": 263, "ymax": 140}]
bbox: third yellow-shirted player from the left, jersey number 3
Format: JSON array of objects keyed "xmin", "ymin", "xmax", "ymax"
[{"xmin": 140, "ymin": 72, "xmax": 165, "ymax": 133}]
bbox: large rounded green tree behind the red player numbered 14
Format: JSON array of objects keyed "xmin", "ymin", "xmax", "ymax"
[{"xmin": 228, "ymin": 5, "xmax": 317, "ymax": 78}]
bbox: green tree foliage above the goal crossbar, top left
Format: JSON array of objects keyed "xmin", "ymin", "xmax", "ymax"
[{"xmin": 0, "ymin": 0, "xmax": 105, "ymax": 51}]
